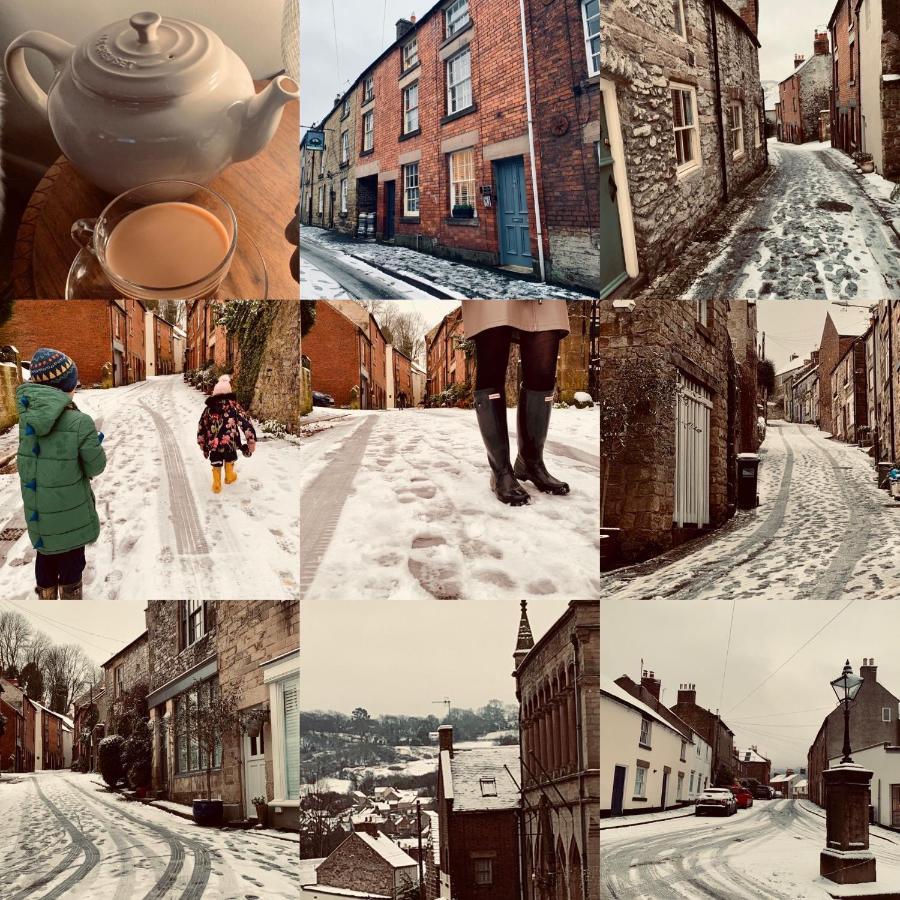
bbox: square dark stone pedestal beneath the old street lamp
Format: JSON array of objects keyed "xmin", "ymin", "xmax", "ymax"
[{"xmin": 819, "ymin": 763, "xmax": 875, "ymax": 884}]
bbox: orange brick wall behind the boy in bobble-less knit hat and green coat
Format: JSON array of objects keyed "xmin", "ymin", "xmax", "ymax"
[{"xmin": 0, "ymin": 300, "xmax": 112, "ymax": 387}]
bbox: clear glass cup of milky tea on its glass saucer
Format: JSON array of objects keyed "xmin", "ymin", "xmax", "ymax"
[{"xmin": 66, "ymin": 180, "xmax": 238, "ymax": 300}]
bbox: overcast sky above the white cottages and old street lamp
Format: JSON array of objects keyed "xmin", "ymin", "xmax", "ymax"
[{"xmin": 600, "ymin": 599, "xmax": 900, "ymax": 769}]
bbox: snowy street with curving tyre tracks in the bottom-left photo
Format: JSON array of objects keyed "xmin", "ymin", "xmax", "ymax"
[{"xmin": 0, "ymin": 771, "xmax": 297, "ymax": 900}]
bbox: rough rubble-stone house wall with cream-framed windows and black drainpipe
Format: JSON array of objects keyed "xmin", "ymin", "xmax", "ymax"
[{"xmin": 600, "ymin": 0, "xmax": 766, "ymax": 276}]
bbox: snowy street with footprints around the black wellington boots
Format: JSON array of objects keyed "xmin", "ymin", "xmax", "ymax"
[{"xmin": 300, "ymin": 408, "xmax": 599, "ymax": 600}]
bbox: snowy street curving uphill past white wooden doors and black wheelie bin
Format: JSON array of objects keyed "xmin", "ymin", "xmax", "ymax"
[{"xmin": 601, "ymin": 421, "xmax": 900, "ymax": 600}]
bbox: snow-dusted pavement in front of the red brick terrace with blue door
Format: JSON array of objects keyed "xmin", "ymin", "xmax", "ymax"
[{"xmin": 300, "ymin": 225, "xmax": 585, "ymax": 300}]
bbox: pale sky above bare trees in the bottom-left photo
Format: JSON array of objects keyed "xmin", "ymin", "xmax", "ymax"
[{"xmin": 8, "ymin": 600, "xmax": 146, "ymax": 665}]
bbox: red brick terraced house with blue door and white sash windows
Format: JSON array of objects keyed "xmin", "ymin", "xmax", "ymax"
[{"xmin": 301, "ymin": 0, "xmax": 600, "ymax": 290}]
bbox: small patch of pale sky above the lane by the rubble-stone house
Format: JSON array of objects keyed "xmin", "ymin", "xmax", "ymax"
[{"xmin": 759, "ymin": 0, "xmax": 835, "ymax": 81}]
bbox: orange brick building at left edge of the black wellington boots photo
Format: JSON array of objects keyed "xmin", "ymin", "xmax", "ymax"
[{"xmin": 303, "ymin": 300, "xmax": 361, "ymax": 407}]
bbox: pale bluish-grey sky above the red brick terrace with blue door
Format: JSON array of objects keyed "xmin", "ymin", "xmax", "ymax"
[{"xmin": 300, "ymin": 0, "xmax": 434, "ymax": 127}]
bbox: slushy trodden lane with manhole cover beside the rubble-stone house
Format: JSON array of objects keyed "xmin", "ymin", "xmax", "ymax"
[{"xmin": 645, "ymin": 139, "xmax": 900, "ymax": 300}]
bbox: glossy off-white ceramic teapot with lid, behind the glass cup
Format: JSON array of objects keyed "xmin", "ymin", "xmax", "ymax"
[{"xmin": 5, "ymin": 12, "xmax": 299, "ymax": 194}]
